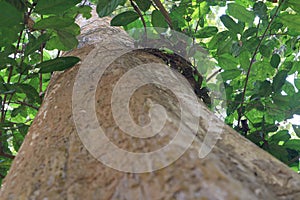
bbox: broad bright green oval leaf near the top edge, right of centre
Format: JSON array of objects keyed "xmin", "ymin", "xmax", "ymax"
[{"xmin": 227, "ymin": 3, "xmax": 254, "ymax": 23}]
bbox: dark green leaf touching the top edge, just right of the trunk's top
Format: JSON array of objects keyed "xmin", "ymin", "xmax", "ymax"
[{"xmin": 96, "ymin": 0, "xmax": 126, "ymax": 17}]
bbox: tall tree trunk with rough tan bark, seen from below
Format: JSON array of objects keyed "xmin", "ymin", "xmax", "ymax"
[{"xmin": 0, "ymin": 12, "xmax": 300, "ymax": 200}]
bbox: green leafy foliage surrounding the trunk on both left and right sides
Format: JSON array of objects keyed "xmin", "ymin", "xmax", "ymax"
[{"xmin": 0, "ymin": 0, "xmax": 300, "ymax": 184}]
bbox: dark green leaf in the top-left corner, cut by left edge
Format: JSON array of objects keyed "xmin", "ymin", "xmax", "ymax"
[{"xmin": 0, "ymin": 1, "xmax": 23, "ymax": 29}]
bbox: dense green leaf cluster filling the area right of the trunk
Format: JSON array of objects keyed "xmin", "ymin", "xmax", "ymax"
[{"xmin": 103, "ymin": 0, "xmax": 300, "ymax": 171}]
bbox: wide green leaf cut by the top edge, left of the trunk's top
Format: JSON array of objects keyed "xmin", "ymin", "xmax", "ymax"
[{"xmin": 34, "ymin": 0, "xmax": 81, "ymax": 15}]
